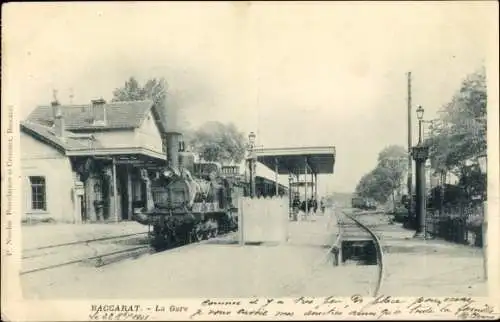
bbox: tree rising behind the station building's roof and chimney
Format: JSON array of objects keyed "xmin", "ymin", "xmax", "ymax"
[{"xmin": 112, "ymin": 76, "xmax": 167, "ymax": 124}]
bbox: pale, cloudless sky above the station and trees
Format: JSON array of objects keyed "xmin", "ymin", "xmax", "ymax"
[{"xmin": 2, "ymin": 1, "xmax": 497, "ymax": 193}]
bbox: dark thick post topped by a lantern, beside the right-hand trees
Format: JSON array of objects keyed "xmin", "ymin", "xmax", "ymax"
[{"xmin": 410, "ymin": 106, "xmax": 429, "ymax": 239}]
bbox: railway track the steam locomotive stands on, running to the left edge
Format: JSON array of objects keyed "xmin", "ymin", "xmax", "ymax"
[{"xmin": 20, "ymin": 232, "xmax": 235, "ymax": 275}]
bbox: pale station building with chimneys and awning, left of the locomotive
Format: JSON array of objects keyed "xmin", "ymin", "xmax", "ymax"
[{"xmin": 20, "ymin": 99, "xmax": 166, "ymax": 223}]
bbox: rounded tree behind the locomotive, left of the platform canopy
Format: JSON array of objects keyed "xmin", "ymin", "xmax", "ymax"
[{"xmin": 187, "ymin": 121, "xmax": 245, "ymax": 164}]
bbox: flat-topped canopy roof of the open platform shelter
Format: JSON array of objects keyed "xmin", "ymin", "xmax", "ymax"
[{"xmin": 255, "ymin": 146, "xmax": 336, "ymax": 174}]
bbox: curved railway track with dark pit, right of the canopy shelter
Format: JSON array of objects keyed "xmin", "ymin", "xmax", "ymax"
[{"xmin": 331, "ymin": 211, "xmax": 384, "ymax": 297}]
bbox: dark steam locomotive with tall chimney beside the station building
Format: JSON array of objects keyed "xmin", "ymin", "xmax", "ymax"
[{"xmin": 133, "ymin": 132, "xmax": 245, "ymax": 250}]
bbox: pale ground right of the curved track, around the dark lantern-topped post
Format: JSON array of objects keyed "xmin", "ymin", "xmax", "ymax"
[{"xmin": 352, "ymin": 214, "xmax": 488, "ymax": 296}]
